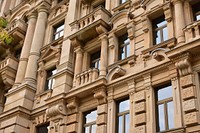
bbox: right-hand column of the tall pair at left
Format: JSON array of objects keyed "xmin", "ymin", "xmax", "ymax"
[{"xmin": 25, "ymin": 5, "xmax": 48, "ymax": 85}]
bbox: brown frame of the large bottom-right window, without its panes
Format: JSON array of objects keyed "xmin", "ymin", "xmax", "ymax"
[{"xmin": 155, "ymin": 83, "xmax": 175, "ymax": 132}]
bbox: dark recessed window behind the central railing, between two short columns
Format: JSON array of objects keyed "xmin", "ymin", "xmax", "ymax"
[{"xmin": 90, "ymin": 51, "xmax": 101, "ymax": 69}]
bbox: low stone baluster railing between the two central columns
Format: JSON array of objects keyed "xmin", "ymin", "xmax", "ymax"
[{"xmin": 76, "ymin": 68, "xmax": 99, "ymax": 87}]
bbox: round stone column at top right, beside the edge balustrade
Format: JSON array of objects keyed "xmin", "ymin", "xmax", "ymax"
[{"xmin": 173, "ymin": 0, "xmax": 185, "ymax": 43}]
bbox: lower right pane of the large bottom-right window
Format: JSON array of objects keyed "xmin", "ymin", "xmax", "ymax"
[{"xmin": 167, "ymin": 101, "xmax": 174, "ymax": 129}]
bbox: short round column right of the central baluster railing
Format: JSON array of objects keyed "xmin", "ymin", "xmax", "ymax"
[{"xmin": 99, "ymin": 34, "xmax": 108, "ymax": 77}]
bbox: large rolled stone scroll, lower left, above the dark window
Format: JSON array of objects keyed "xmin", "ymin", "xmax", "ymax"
[{"xmin": 46, "ymin": 104, "xmax": 66, "ymax": 117}]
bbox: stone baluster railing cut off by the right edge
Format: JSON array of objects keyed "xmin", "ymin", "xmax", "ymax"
[{"xmin": 184, "ymin": 21, "xmax": 200, "ymax": 42}]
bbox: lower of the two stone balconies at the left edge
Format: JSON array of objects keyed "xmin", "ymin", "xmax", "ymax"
[{"xmin": 0, "ymin": 57, "xmax": 18, "ymax": 87}]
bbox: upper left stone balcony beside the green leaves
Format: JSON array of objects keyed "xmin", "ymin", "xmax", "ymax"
[{"xmin": 8, "ymin": 19, "xmax": 27, "ymax": 43}]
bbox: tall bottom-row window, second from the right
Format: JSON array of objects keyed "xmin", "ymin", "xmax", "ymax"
[{"xmin": 117, "ymin": 99, "xmax": 130, "ymax": 133}]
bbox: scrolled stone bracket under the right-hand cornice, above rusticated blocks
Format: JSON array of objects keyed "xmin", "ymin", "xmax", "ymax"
[{"xmin": 175, "ymin": 59, "xmax": 192, "ymax": 76}]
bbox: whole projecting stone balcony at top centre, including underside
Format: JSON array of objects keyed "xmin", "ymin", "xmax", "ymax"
[{"xmin": 69, "ymin": 6, "xmax": 111, "ymax": 42}]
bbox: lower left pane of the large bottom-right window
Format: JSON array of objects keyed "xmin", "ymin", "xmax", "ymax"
[{"xmin": 158, "ymin": 104, "xmax": 165, "ymax": 131}]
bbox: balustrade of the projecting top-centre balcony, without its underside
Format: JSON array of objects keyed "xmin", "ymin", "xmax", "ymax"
[{"xmin": 70, "ymin": 6, "xmax": 110, "ymax": 31}]
